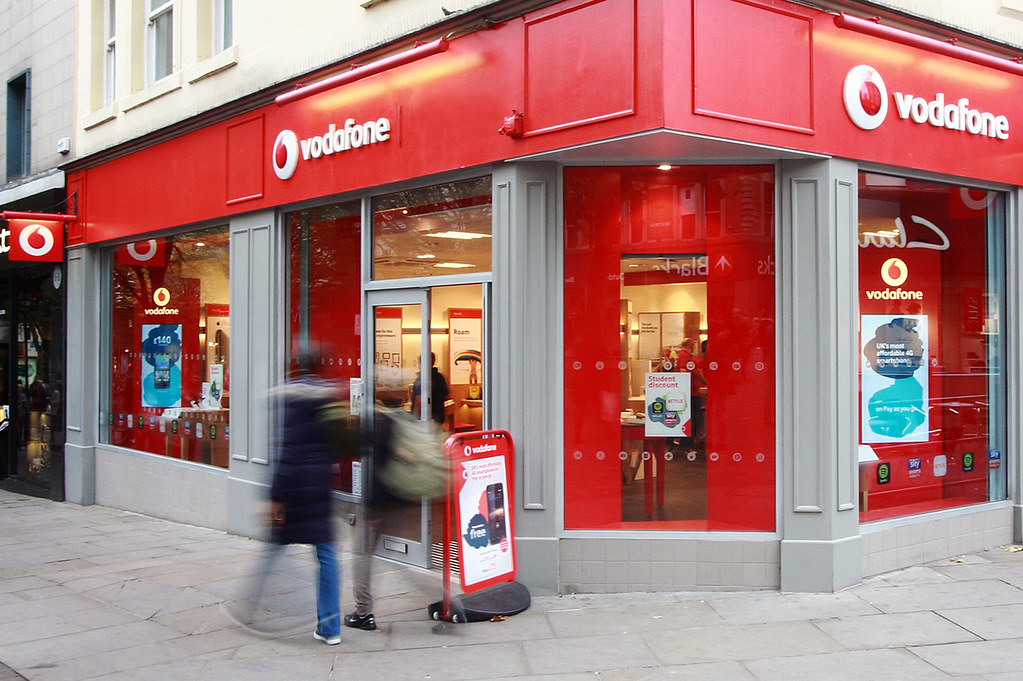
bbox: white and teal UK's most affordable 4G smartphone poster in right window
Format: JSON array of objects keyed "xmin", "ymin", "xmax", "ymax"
[{"xmin": 860, "ymin": 315, "xmax": 929, "ymax": 443}]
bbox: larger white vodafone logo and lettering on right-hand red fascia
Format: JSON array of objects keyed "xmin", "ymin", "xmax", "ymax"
[{"xmin": 842, "ymin": 64, "xmax": 1009, "ymax": 140}]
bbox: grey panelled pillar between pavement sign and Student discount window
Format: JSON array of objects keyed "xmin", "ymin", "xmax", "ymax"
[{"xmin": 491, "ymin": 164, "xmax": 563, "ymax": 594}]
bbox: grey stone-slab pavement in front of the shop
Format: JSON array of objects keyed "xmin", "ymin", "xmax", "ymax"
[{"xmin": 0, "ymin": 491, "xmax": 1023, "ymax": 681}]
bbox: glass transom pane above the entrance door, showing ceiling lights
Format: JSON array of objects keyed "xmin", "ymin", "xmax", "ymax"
[{"xmin": 373, "ymin": 177, "xmax": 492, "ymax": 279}]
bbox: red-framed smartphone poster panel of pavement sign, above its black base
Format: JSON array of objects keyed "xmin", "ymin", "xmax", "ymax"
[{"xmin": 453, "ymin": 436, "xmax": 516, "ymax": 593}]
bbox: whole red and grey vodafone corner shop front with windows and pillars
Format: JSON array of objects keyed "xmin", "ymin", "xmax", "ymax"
[{"xmin": 65, "ymin": 0, "xmax": 1023, "ymax": 593}]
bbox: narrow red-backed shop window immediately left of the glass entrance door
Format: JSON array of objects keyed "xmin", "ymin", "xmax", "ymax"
[{"xmin": 287, "ymin": 200, "xmax": 362, "ymax": 493}]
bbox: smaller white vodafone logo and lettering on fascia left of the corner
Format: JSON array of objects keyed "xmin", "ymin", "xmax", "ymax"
[{"xmin": 271, "ymin": 118, "xmax": 391, "ymax": 180}]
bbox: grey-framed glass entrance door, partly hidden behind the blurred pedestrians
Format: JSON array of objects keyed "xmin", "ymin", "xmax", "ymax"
[{"xmin": 364, "ymin": 288, "xmax": 431, "ymax": 568}]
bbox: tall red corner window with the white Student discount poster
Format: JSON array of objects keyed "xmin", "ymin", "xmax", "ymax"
[{"xmin": 564, "ymin": 167, "xmax": 775, "ymax": 531}]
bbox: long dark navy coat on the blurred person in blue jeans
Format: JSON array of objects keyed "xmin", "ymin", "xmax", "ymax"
[{"xmin": 270, "ymin": 375, "xmax": 337, "ymax": 544}]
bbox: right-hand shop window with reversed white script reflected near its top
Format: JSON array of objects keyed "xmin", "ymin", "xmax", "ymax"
[{"xmin": 859, "ymin": 173, "xmax": 1007, "ymax": 521}]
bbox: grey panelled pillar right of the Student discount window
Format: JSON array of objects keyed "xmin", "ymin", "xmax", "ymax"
[{"xmin": 777, "ymin": 160, "xmax": 862, "ymax": 592}]
